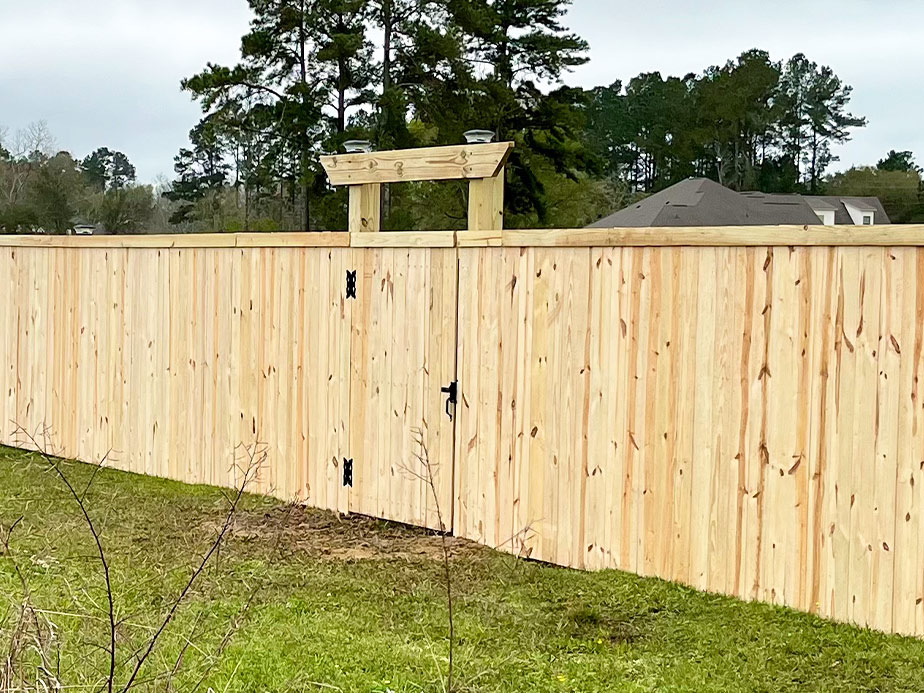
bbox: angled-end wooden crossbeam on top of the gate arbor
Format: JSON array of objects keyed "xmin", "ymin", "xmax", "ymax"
[{"xmin": 321, "ymin": 142, "xmax": 514, "ymax": 185}]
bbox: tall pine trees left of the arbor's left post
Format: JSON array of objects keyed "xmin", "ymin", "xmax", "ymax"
[{"xmin": 180, "ymin": 0, "xmax": 372, "ymax": 230}]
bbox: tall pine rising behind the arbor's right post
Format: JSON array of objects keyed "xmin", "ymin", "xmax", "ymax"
[{"xmin": 429, "ymin": 0, "xmax": 596, "ymax": 225}]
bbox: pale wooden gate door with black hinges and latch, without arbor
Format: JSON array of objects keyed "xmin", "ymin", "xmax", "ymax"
[{"xmin": 349, "ymin": 243, "xmax": 458, "ymax": 530}]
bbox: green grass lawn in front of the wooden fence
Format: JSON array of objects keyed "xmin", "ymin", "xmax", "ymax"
[{"xmin": 0, "ymin": 448, "xmax": 924, "ymax": 693}]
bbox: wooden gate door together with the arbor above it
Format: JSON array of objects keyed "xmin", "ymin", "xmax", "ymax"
[{"xmin": 321, "ymin": 142, "xmax": 513, "ymax": 530}]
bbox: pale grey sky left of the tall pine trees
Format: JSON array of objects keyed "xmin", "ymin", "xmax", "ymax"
[{"xmin": 0, "ymin": 0, "xmax": 249, "ymax": 181}]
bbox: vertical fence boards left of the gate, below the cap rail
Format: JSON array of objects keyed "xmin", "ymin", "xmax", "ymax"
[{"xmin": 0, "ymin": 247, "xmax": 351, "ymax": 511}]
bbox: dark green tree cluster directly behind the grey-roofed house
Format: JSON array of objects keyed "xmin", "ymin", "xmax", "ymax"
[{"xmin": 588, "ymin": 50, "xmax": 866, "ymax": 193}]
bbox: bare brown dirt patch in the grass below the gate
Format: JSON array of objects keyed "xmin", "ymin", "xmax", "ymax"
[{"xmin": 225, "ymin": 505, "xmax": 485, "ymax": 561}]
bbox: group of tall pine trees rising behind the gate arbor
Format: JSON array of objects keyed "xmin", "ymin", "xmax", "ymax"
[{"xmin": 179, "ymin": 0, "xmax": 596, "ymax": 228}]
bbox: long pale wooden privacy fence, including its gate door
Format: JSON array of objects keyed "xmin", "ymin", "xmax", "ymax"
[{"xmin": 0, "ymin": 142, "xmax": 924, "ymax": 635}]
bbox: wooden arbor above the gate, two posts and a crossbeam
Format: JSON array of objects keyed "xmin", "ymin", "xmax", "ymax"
[{"xmin": 321, "ymin": 142, "xmax": 513, "ymax": 231}]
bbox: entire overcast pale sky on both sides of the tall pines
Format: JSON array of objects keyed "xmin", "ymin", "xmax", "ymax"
[{"xmin": 0, "ymin": 0, "xmax": 924, "ymax": 182}]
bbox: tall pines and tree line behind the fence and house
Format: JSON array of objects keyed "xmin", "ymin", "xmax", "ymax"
[{"xmin": 0, "ymin": 0, "xmax": 921, "ymax": 231}]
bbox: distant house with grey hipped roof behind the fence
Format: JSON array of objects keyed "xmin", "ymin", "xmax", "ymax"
[{"xmin": 588, "ymin": 178, "xmax": 891, "ymax": 228}]
